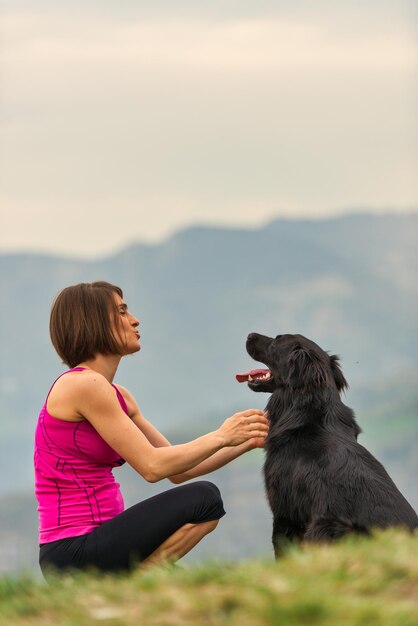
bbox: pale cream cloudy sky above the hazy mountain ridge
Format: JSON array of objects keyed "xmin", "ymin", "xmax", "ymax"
[{"xmin": 0, "ymin": 0, "xmax": 418, "ymax": 258}]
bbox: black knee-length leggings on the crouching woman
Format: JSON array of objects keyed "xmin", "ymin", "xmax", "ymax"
[{"xmin": 39, "ymin": 480, "xmax": 225, "ymax": 578}]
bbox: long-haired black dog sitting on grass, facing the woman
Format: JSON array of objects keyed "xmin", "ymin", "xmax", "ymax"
[{"xmin": 237, "ymin": 333, "xmax": 418, "ymax": 557}]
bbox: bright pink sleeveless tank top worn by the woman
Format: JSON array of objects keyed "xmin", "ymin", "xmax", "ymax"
[{"xmin": 34, "ymin": 367, "xmax": 128, "ymax": 543}]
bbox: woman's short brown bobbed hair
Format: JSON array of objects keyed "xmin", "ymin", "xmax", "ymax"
[{"xmin": 49, "ymin": 281, "xmax": 123, "ymax": 367}]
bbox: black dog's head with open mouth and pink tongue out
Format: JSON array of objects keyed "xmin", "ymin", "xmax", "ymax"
[{"xmin": 237, "ymin": 333, "xmax": 348, "ymax": 393}]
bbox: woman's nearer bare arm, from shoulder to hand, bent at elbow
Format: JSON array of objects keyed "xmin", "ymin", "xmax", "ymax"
[{"xmin": 72, "ymin": 372, "xmax": 267, "ymax": 482}]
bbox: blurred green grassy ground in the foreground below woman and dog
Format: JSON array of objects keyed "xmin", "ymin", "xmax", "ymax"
[{"xmin": 0, "ymin": 531, "xmax": 418, "ymax": 626}]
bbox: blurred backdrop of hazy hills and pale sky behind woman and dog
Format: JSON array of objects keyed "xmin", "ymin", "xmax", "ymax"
[{"xmin": 0, "ymin": 0, "xmax": 418, "ymax": 572}]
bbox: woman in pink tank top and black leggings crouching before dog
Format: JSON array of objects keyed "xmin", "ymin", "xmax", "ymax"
[{"xmin": 34, "ymin": 282, "xmax": 268, "ymax": 573}]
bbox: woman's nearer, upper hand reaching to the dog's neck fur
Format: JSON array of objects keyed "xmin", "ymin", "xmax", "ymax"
[{"xmin": 218, "ymin": 409, "xmax": 268, "ymax": 448}]
